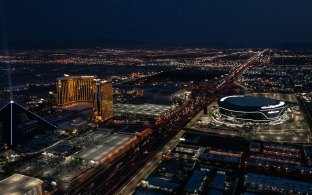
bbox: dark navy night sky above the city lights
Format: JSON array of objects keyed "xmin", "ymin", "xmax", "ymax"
[{"xmin": 0, "ymin": 0, "xmax": 312, "ymax": 48}]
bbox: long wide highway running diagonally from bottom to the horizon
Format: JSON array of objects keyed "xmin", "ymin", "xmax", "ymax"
[{"xmin": 67, "ymin": 50, "xmax": 266, "ymax": 195}]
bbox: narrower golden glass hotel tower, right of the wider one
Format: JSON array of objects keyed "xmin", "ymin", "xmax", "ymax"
[{"xmin": 93, "ymin": 80, "xmax": 113, "ymax": 121}]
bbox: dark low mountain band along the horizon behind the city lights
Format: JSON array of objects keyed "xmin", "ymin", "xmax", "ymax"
[{"xmin": 0, "ymin": 40, "xmax": 312, "ymax": 52}]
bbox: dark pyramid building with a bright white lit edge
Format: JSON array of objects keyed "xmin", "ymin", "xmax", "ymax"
[{"xmin": 0, "ymin": 101, "xmax": 56, "ymax": 147}]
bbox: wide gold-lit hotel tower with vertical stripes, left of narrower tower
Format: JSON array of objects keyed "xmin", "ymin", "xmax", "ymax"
[{"xmin": 56, "ymin": 76, "xmax": 95, "ymax": 106}]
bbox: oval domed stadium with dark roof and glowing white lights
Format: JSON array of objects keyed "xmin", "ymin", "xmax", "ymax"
[{"xmin": 218, "ymin": 95, "xmax": 287, "ymax": 122}]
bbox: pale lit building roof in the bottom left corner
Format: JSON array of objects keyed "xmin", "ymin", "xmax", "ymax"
[{"xmin": 0, "ymin": 174, "xmax": 43, "ymax": 195}]
